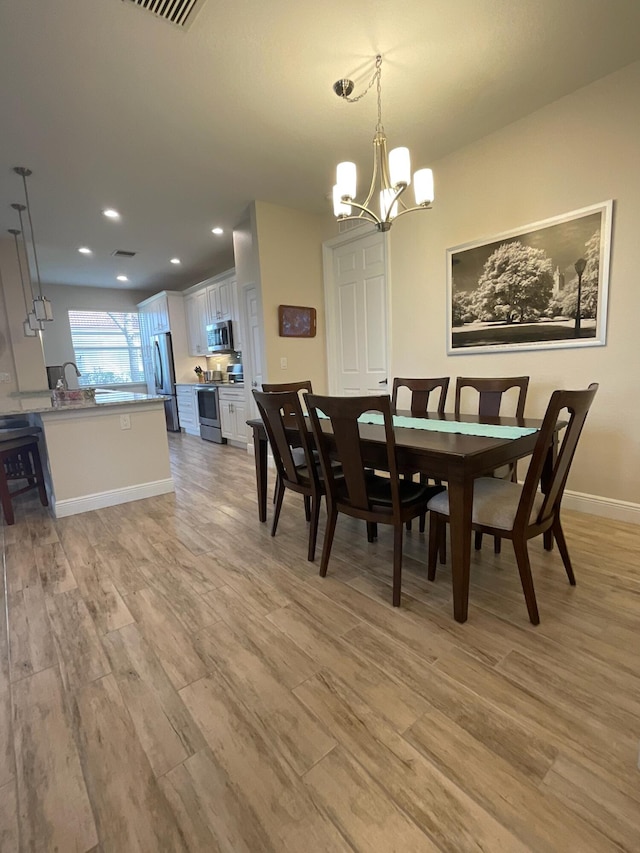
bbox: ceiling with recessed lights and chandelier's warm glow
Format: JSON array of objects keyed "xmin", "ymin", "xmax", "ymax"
[{"xmin": 0, "ymin": 0, "xmax": 640, "ymax": 291}]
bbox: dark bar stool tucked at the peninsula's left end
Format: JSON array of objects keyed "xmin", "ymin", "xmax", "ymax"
[{"xmin": 0, "ymin": 427, "xmax": 49, "ymax": 524}]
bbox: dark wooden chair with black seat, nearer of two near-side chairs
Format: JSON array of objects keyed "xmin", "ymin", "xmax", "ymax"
[{"xmin": 307, "ymin": 394, "xmax": 444, "ymax": 607}]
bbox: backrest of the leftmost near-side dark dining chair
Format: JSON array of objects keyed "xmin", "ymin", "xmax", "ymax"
[{"xmin": 253, "ymin": 389, "xmax": 318, "ymax": 485}]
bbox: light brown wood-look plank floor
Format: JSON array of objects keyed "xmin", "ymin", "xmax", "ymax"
[{"xmin": 0, "ymin": 435, "xmax": 640, "ymax": 853}]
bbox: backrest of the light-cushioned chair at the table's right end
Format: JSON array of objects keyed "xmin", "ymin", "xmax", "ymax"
[{"xmin": 514, "ymin": 382, "xmax": 598, "ymax": 527}]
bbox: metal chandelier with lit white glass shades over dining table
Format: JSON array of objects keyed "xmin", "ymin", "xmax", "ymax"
[{"xmin": 333, "ymin": 55, "xmax": 433, "ymax": 231}]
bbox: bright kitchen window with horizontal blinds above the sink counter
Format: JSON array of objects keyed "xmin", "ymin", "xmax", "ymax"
[{"xmin": 69, "ymin": 311, "xmax": 144, "ymax": 385}]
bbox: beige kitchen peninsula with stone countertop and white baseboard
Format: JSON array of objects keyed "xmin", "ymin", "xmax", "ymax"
[{"xmin": 0, "ymin": 389, "xmax": 174, "ymax": 518}]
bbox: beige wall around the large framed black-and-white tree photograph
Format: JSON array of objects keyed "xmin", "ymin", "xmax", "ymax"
[{"xmin": 390, "ymin": 63, "xmax": 640, "ymax": 504}]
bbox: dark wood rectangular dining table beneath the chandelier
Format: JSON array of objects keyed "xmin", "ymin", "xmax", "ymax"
[{"xmin": 247, "ymin": 412, "xmax": 562, "ymax": 622}]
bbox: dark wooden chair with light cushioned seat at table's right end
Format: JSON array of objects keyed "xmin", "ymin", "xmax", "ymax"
[{"xmin": 428, "ymin": 382, "xmax": 598, "ymax": 625}]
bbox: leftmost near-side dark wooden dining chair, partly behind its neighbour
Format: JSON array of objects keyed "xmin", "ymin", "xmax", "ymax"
[{"xmin": 253, "ymin": 390, "xmax": 325, "ymax": 562}]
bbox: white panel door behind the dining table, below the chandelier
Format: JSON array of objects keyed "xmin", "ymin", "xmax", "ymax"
[{"xmin": 329, "ymin": 233, "xmax": 388, "ymax": 396}]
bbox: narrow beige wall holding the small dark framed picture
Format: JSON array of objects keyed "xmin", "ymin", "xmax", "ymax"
[{"xmin": 255, "ymin": 201, "xmax": 328, "ymax": 393}]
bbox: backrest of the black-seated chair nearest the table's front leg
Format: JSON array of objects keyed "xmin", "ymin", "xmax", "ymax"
[{"xmin": 307, "ymin": 394, "xmax": 400, "ymax": 511}]
